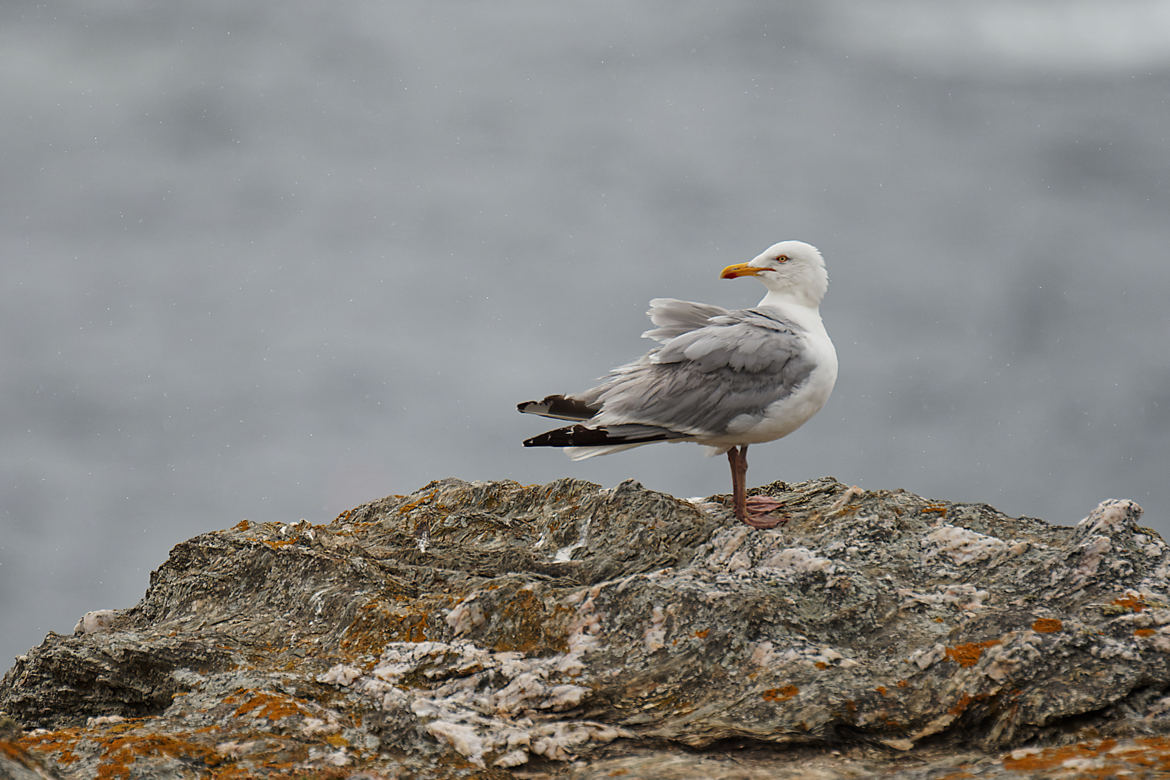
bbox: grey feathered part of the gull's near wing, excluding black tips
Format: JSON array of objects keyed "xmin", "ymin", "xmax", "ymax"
[{"xmin": 581, "ymin": 309, "xmax": 814, "ymax": 435}]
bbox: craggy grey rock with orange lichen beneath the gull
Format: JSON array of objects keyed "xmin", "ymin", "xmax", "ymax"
[{"xmin": 0, "ymin": 478, "xmax": 1170, "ymax": 779}]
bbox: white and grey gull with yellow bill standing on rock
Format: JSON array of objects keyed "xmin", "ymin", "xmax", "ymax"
[{"xmin": 516, "ymin": 241, "xmax": 837, "ymax": 529}]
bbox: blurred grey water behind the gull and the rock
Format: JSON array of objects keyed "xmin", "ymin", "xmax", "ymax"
[{"xmin": 0, "ymin": 0, "xmax": 1170, "ymax": 668}]
